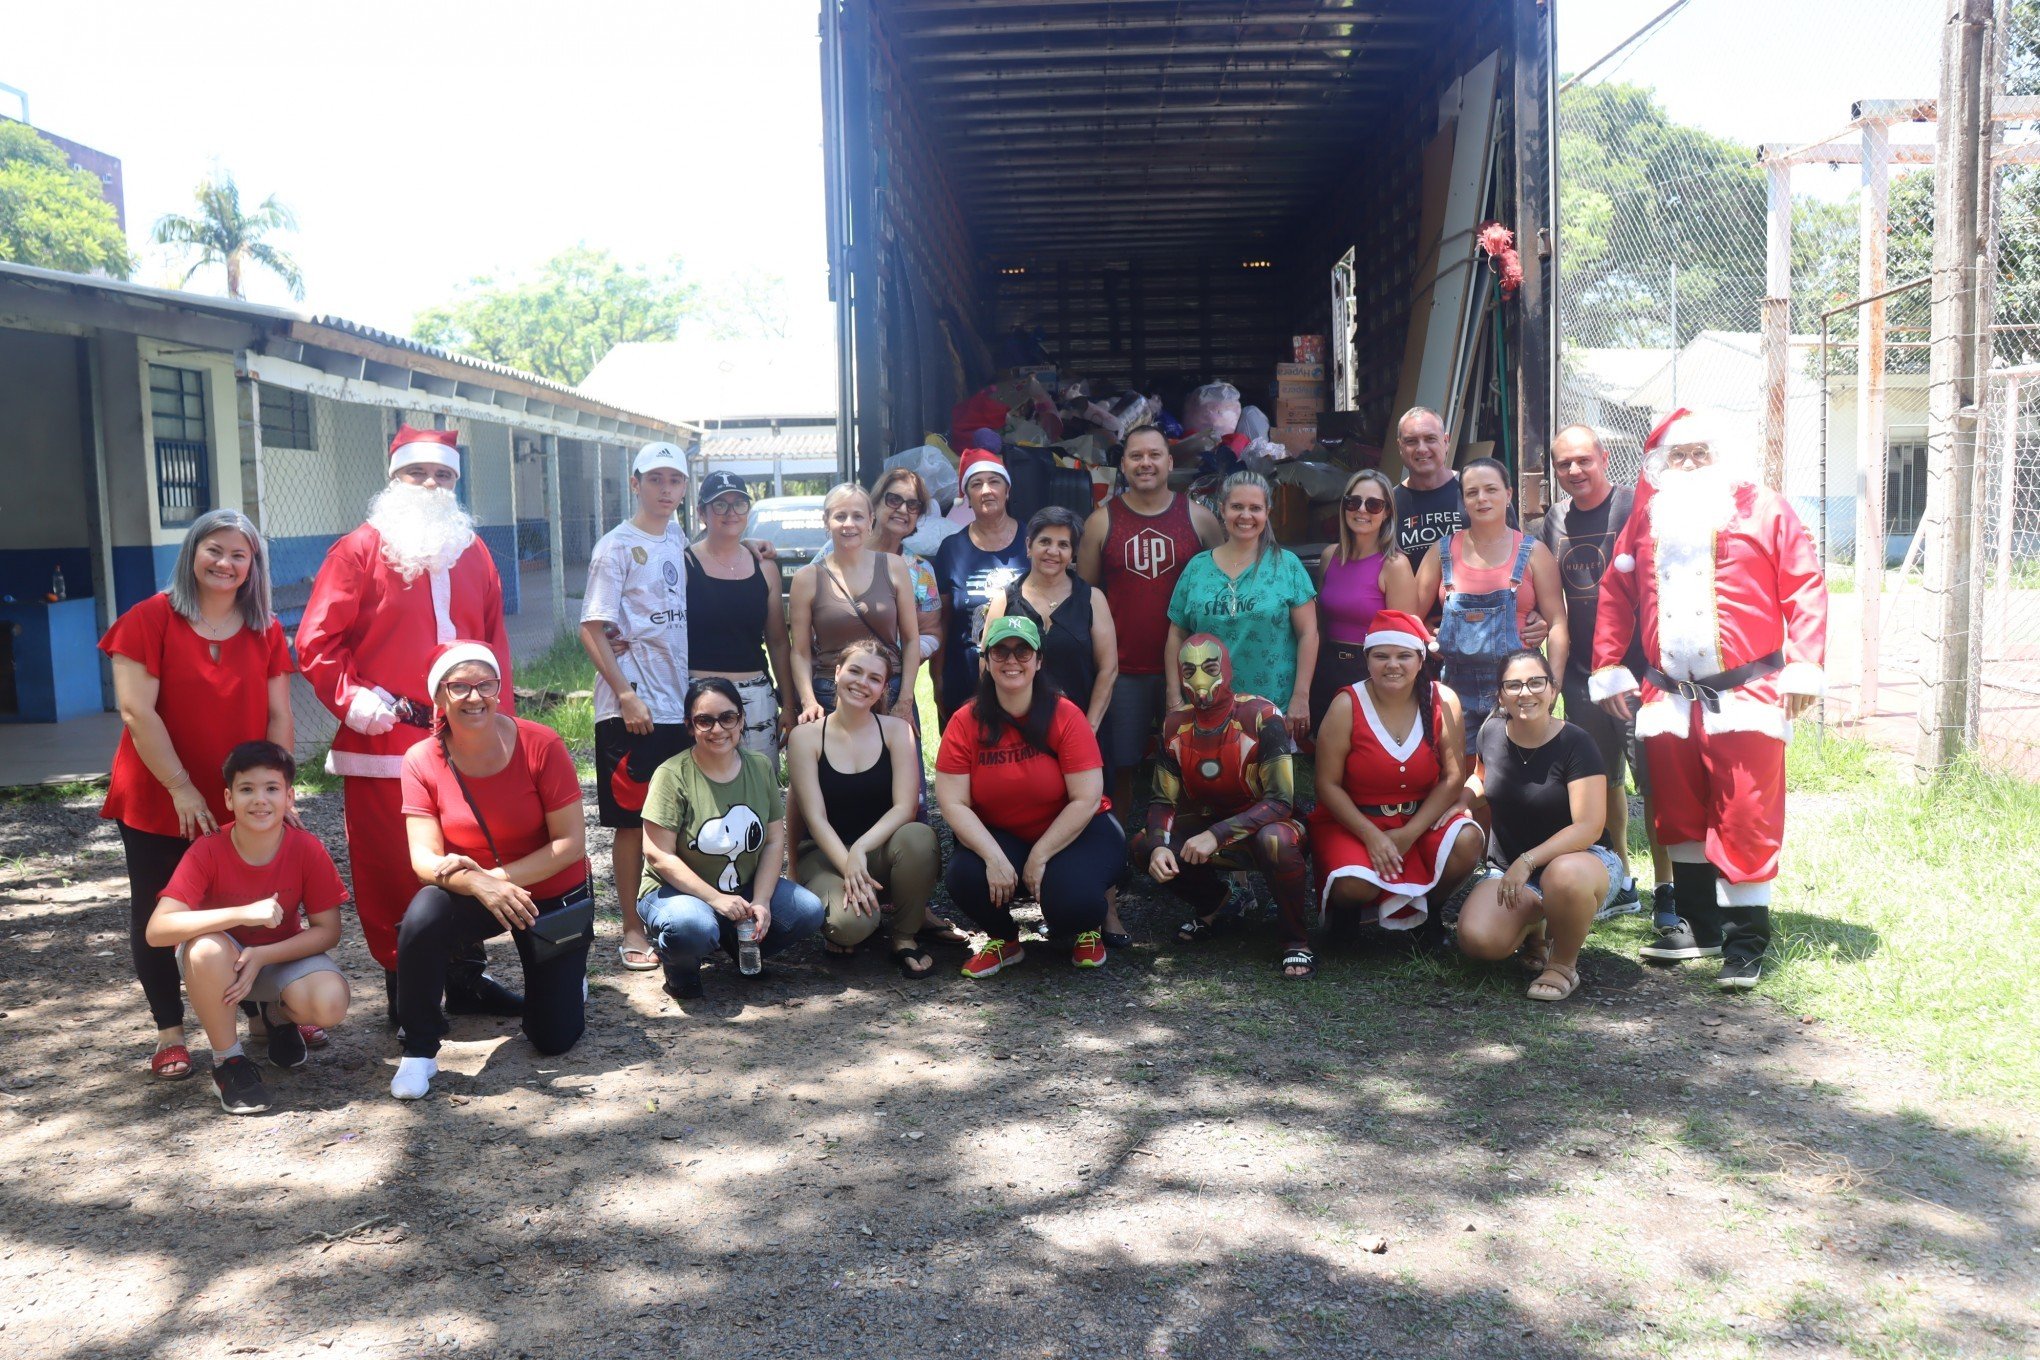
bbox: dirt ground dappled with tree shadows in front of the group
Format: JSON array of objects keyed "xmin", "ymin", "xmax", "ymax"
[{"xmin": 0, "ymin": 774, "xmax": 2040, "ymax": 1360}]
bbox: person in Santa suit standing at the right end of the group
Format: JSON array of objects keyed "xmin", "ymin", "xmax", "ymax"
[{"xmin": 1587, "ymin": 408, "xmax": 1828, "ymax": 991}]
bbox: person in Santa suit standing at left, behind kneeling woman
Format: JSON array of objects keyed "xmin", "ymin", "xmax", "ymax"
[{"xmin": 298, "ymin": 424, "xmax": 524, "ymax": 1024}]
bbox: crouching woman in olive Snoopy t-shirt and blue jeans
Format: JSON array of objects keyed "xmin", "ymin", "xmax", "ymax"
[{"xmin": 639, "ymin": 675, "xmax": 826, "ymax": 1001}]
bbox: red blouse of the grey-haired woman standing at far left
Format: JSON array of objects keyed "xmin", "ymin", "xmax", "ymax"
[{"xmin": 100, "ymin": 595, "xmax": 298, "ymax": 840}]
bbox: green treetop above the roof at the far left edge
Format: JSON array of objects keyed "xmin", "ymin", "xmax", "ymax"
[{"xmin": 0, "ymin": 120, "xmax": 135, "ymax": 279}]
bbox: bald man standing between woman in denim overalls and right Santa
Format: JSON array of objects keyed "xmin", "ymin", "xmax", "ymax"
[{"xmin": 1538, "ymin": 424, "xmax": 1679, "ymax": 920}]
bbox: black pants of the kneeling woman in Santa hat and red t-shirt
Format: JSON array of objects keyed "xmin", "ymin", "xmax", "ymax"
[{"xmin": 396, "ymin": 887, "xmax": 588, "ymax": 1058}]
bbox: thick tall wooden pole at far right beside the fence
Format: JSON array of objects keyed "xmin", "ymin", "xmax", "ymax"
[{"xmin": 1914, "ymin": 0, "xmax": 1993, "ymax": 779}]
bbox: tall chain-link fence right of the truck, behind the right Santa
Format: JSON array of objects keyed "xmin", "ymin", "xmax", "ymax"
[{"xmin": 1559, "ymin": 0, "xmax": 2040, "ymax": 775}]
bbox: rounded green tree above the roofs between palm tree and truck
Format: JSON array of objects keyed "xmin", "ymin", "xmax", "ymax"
[{"xmin": 412, "ymin": 243, "xmax": 700, "ymax": 385}]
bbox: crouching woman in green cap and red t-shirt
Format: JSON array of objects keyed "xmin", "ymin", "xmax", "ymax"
[{"xmin": 934, "ymin": 618, "xmax": 1126, "ymax": 977}]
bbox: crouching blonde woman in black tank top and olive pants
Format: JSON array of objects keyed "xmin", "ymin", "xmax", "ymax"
[{"xmin": 785, "ymin": 638, "xmax": 942, "ymax": 979}]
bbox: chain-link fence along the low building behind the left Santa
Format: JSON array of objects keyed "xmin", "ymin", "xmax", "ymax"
[{"xmin": 241, "ymin": 379, "xmax": 630, "ymax": 756}]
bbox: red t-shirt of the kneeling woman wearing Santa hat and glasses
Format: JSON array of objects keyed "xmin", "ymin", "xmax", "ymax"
[{"xmin": 404, "ymin": 718, "xmax": 588, "ymax": 897}]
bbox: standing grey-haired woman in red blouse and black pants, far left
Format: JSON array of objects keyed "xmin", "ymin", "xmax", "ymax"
[{"xmin": 100, "ymin": 510, "xmax": 296, "ymax": 1081}]
